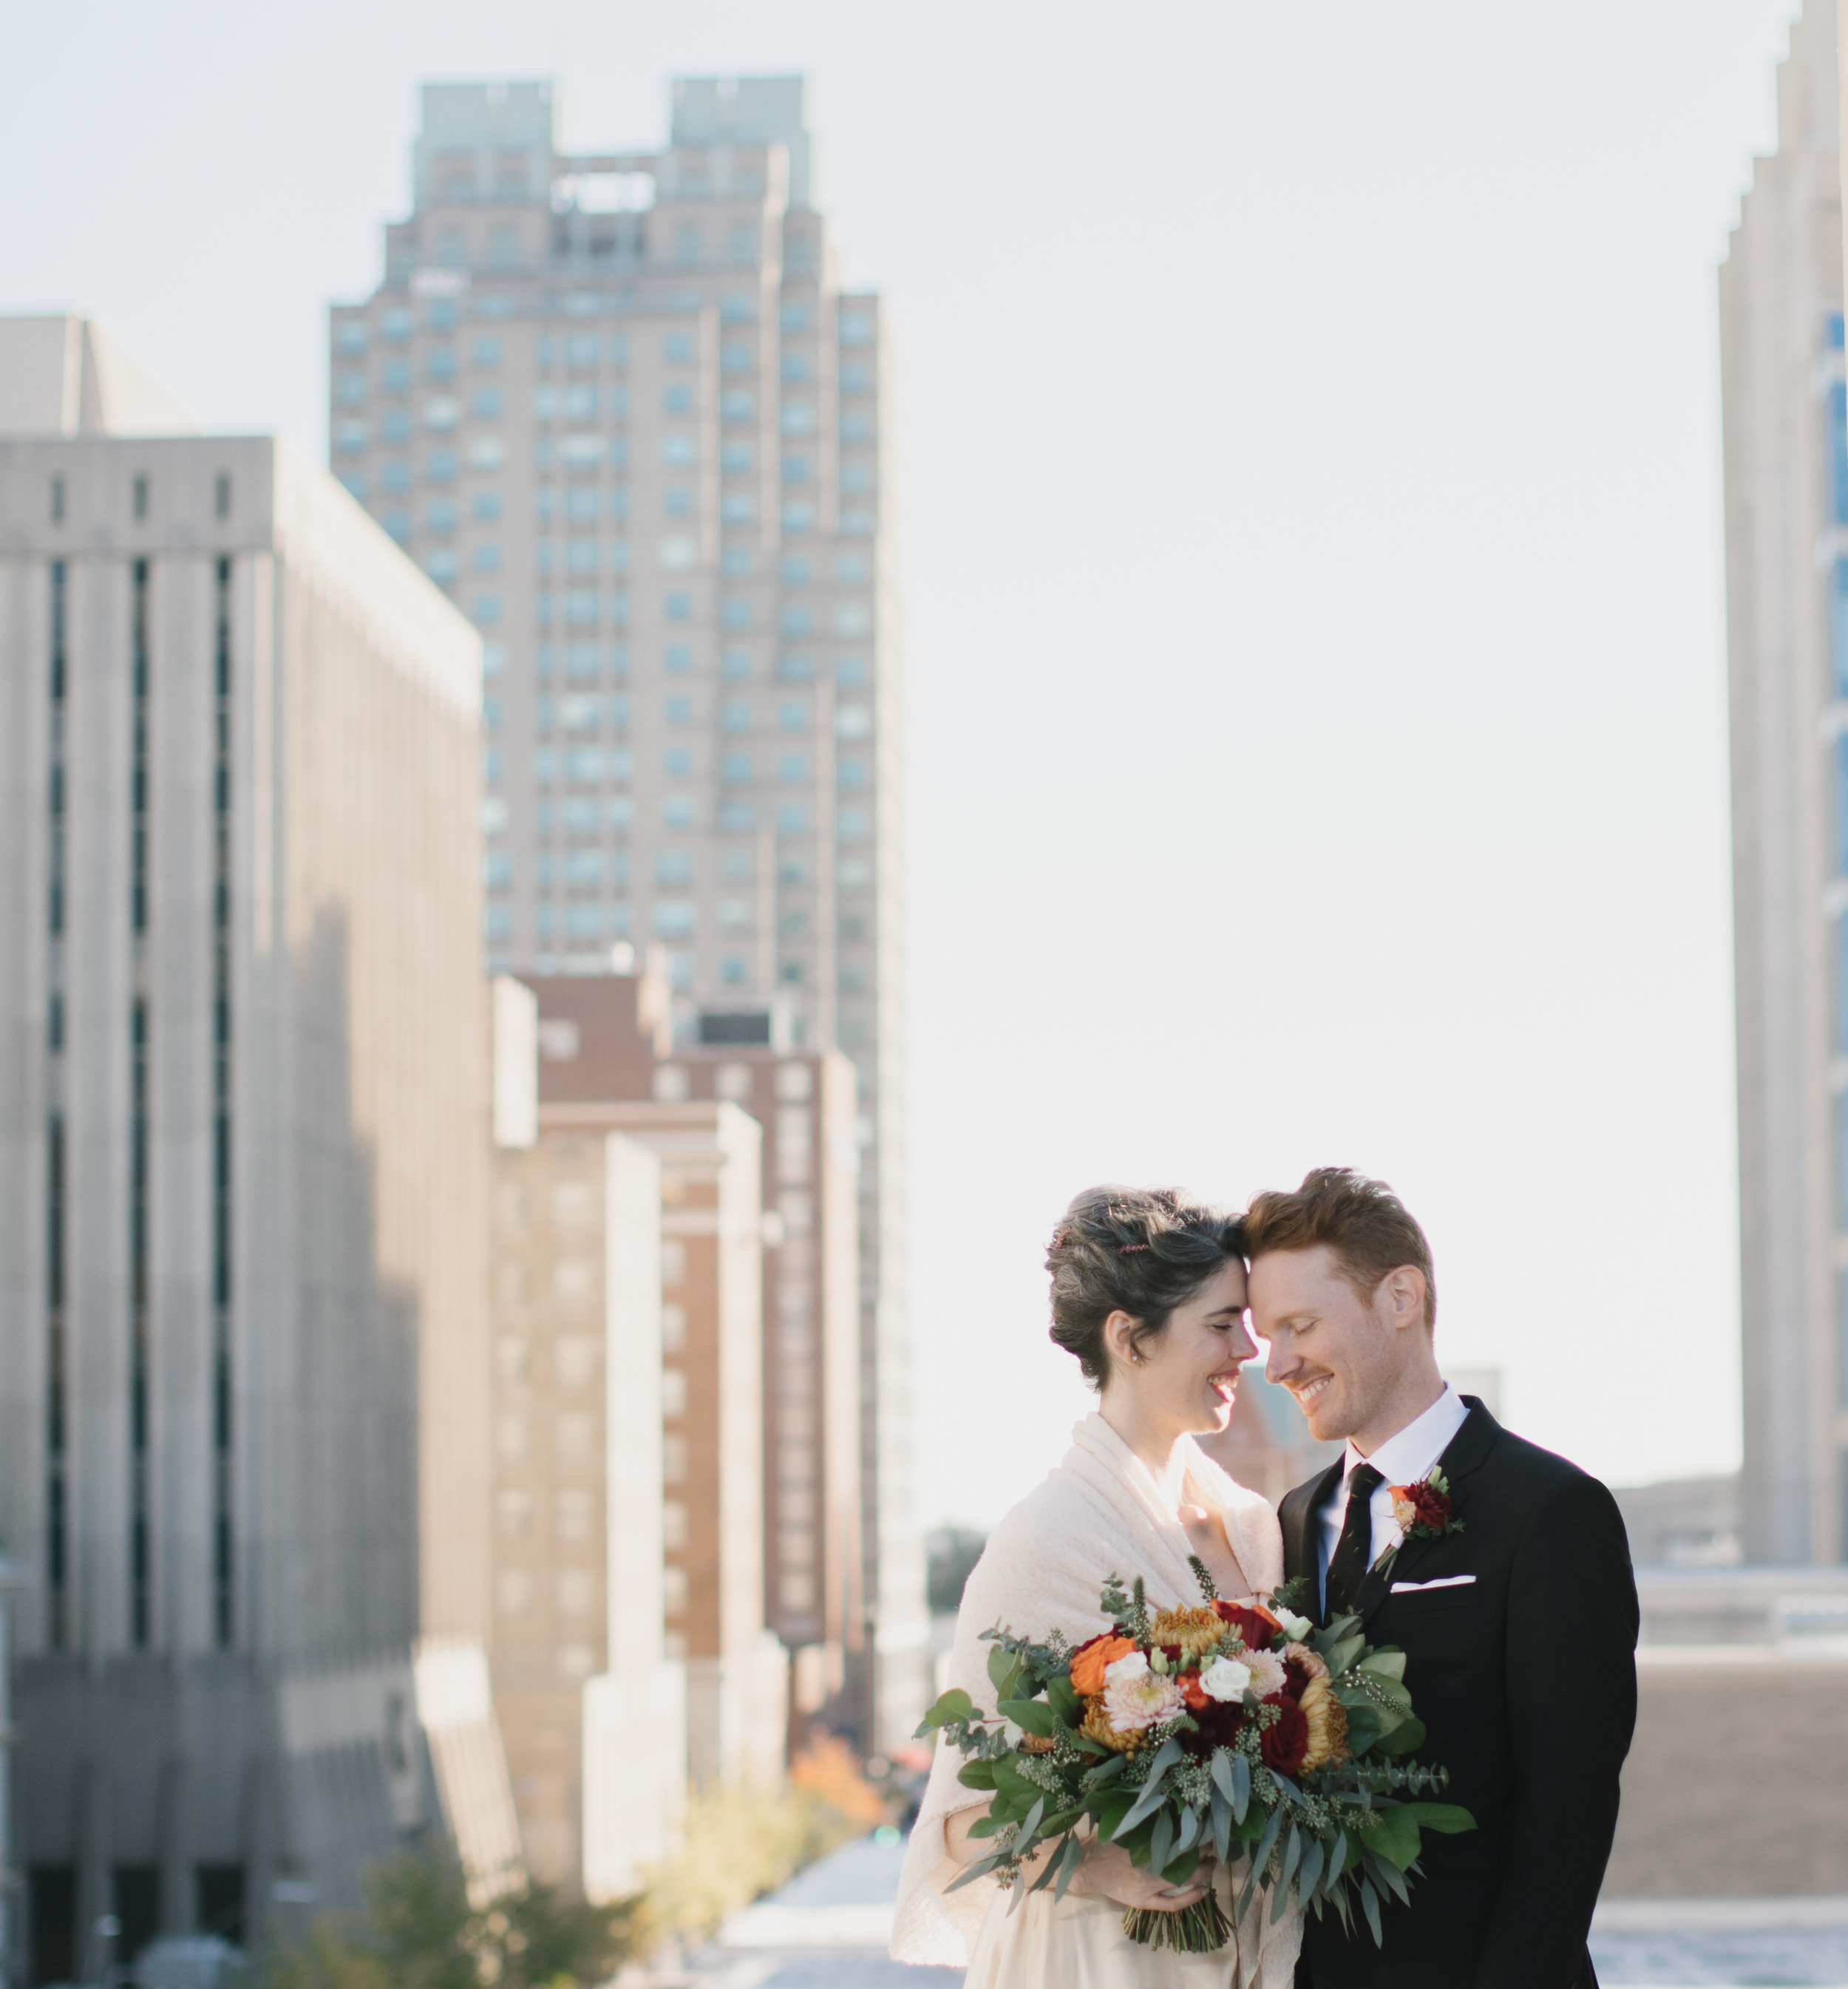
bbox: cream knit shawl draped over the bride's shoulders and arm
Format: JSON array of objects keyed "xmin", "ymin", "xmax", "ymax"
[{"xmin": 891, "ymin": 1412, "xmax": 1299, "ymax": 1989}]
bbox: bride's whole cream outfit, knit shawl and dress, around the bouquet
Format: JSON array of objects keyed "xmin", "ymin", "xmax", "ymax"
[{"xmin": 891, "ymin": 1414, "xmax": 1303, "ymax": 1989}]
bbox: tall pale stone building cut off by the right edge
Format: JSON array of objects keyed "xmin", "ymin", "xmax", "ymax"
[{"xmin": 1721, "ymin": 0, "xmax": 1848, "ymax": 1561}]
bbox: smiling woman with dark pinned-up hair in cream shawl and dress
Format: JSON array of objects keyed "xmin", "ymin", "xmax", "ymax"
[{"xmin": 891, "ymin": 1188, "xmax": 1301, "ymax": 1989}]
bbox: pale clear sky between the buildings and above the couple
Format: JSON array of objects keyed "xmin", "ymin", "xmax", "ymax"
[{"xmin": 0, "ymin": 0, "xmax": 1814, "ymax": 1526}]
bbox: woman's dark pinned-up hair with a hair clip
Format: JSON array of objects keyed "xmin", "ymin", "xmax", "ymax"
[{"xmin": 1047, "ymin": 1188, "xmax": 1246, "ymax": 1388}]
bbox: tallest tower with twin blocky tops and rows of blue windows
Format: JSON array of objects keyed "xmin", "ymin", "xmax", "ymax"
[{"xmin": 330, "ymin": 78, "xmax": 927, "ymax": 1744}]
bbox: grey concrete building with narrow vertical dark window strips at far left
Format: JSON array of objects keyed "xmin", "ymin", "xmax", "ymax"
[{"xmin": 0, "ymin": 320, "xmax": 519, "ymax": 1981}]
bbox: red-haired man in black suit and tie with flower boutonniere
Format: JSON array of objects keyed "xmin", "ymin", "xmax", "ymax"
[{"xmin": 1246, "ymin": 1168, "xmax": 1637, "ymax": 1989}]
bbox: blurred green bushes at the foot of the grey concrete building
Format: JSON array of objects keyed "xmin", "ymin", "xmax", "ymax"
[{"xmin": 265, "ymin": 1844, "xmax": 639, "ymax": 1989}]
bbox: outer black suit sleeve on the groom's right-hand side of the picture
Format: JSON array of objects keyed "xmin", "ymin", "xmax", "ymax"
[{"xmin": 1476, "ymin": 1474, "xmax": 1637, "ymax": 1989}]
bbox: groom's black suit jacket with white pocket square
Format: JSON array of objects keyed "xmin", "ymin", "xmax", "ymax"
[{"xmin": 1279, "ymin": 1396, "xmax": 1637, "ymax": 1989}]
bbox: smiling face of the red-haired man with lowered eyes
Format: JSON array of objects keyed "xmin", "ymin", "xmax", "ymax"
[{"xmin": 1249, "ymin": 1243, "xmax": 1424, "ymax": 1442}]
